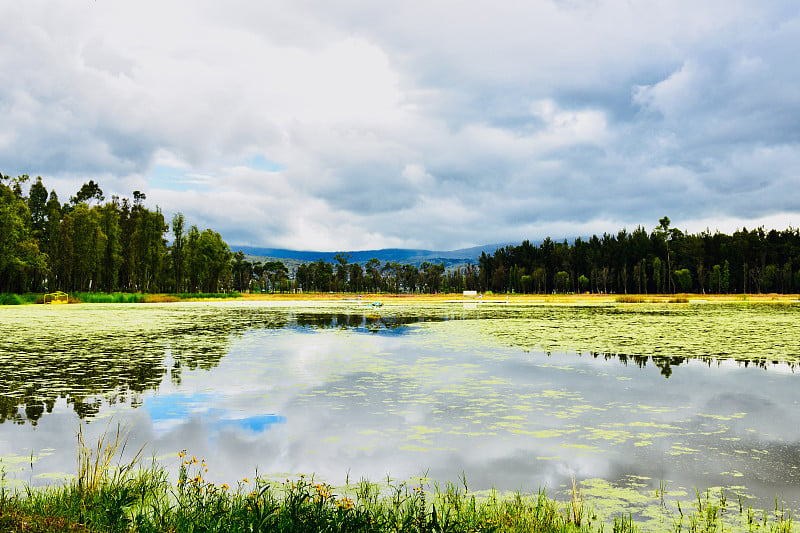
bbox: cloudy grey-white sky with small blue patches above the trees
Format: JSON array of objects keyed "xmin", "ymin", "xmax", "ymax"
[{"xmin": 0, "ymin": 0, "xmax": 800, "ymax": 251}]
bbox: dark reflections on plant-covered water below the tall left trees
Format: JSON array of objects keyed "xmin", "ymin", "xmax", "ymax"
[{"xmin": 0, "ymin": 309, "xmax": 286, "ymax": 425}]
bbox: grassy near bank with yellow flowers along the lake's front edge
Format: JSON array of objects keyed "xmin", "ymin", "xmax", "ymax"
[{"xmin": 0, "ymin": 429, "xmax": 797, "ymax": 533}]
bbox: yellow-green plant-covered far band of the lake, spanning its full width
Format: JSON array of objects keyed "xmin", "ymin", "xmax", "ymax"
[{"xmin": 0, "ymin": 304, "xmax": 800, "ymax": 425}]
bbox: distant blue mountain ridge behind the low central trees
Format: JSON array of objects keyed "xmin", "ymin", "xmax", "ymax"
[{"xmin": 231, "ymin": 244, "xmax": 506, "ymax": 266}]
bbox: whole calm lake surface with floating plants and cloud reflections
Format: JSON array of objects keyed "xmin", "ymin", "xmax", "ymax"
[{"xmin": 0, "ymin": 302, "xmax": 800, "ymax": 509}]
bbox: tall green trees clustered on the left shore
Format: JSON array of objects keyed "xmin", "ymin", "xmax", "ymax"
[{"xmin": 0, "ymin": 174, "xmax": 232, "ymax": 293}]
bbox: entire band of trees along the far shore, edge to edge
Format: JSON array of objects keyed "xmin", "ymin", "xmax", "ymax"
[{"xmin": 0, "ymin": 174, "xmax": 800, "ymax": 294}]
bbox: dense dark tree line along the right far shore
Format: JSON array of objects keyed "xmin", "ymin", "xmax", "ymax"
[{"xmin": 478, "ymin": 217, "xmax": 800, "ymax": 294}]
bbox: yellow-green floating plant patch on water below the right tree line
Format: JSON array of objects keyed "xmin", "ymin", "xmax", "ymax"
[{"xmin": 480, "ymin": 304, "xmax": 800, "ymax": 378}]
